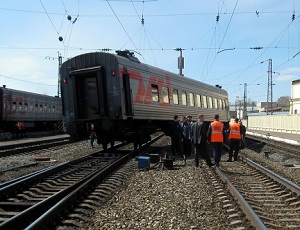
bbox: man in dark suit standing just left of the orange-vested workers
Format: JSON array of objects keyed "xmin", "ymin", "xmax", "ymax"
[{"xmin": 191, "ymin": 114, "xmax": 214, "ymax": 167}]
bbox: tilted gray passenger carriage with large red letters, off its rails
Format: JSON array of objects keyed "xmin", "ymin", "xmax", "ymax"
[{"xmin": 60, "ymin": 51, "xmax": 229, "ymax": 148}]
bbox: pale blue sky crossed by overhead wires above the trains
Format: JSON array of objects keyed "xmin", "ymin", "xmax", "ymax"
[{"xmin": 0, "ymin": 0, "xmax": 300, "ymax": 103}]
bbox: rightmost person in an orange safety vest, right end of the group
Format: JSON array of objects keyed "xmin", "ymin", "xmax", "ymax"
[{"xmin": 227, "ymin": 118, "xmax": 242, "ymax": 162}]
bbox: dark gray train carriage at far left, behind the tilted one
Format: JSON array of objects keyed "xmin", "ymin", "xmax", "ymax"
[{"xmin": 0, "ymin": 87, "xmax": 63, "ymax": 132}]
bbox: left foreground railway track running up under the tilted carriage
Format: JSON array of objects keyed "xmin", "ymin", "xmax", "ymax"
[{"xmin": 0, "ymin": 133, "xmax": 160, "ymax": 229}]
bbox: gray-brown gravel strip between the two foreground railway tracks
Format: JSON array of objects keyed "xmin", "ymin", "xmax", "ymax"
[{"xmin": 89, "ymin": 137, "xmax": 232, "ymax": 230}]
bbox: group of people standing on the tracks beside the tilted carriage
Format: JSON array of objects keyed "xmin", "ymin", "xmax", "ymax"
[{"xmin": 171, "ymin": 114, "xmax": 246, "ymax": 167}]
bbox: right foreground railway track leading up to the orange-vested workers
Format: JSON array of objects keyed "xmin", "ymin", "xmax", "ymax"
[{"xmin": 217, "ymin": 157, "xmax": 300, "ymax": 229}]
